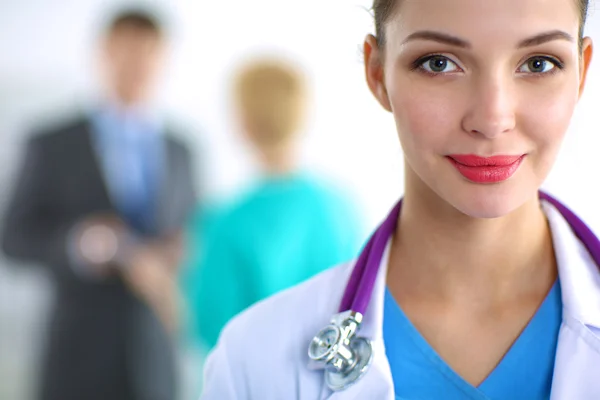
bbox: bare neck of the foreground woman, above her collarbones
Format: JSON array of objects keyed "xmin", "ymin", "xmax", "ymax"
[{"xmin": 388, "ymin": 170, "xmax": 557, "ymax": 307}]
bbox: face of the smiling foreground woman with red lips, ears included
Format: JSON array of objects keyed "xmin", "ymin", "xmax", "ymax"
[{"xmin": 365, "ymin": 0, "xmax": 591, "ymax": 218}]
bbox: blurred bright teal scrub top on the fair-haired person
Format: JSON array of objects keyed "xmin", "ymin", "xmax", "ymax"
[{"xmin": 182, "ymin": 174, "xmax": 366, "ymax": 350}]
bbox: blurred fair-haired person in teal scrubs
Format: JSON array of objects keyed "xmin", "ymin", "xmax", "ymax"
[{"xmin": 182, "ymin": 59, "xmax": 364, "ymax": 350}]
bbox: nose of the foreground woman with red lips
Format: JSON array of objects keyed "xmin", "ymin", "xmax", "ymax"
[{"xmin": 462, "ymin": 74, "xmax": 516, "ymax": 139}]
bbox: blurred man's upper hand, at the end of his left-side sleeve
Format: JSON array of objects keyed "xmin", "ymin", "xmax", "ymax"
[{"xmin": 74, "ymin": 213, "xmax": 127, "ymax": 276}]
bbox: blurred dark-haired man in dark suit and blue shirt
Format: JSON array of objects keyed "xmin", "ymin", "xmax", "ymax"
[{"xmin": 2, "ymin": 9, "xmax": 196, "ymax": 400}]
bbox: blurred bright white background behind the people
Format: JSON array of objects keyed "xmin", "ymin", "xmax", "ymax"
[{"xmin": 0, "ymin": 0, "xmax": 600, "ymax": 399}]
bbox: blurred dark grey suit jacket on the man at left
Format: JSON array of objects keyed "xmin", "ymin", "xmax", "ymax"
[{"xmin": 2, "ymin": 118, "xmax": 195, "ymax": 400}]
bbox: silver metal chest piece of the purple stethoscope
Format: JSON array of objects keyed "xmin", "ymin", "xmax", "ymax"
[{"xmin": 308, "ymin": 311, "xmax": 373, "ymax": 391}]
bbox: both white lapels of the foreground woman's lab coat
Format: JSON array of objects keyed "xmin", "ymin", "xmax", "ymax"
[{"xmin": 320, "ymin": 201, "xmax": 600, "ymax": 400}]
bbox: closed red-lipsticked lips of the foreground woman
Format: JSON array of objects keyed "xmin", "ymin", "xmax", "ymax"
[{"xmin": 447, "ymin": 154, "xmax": 525, "ymax": 183}]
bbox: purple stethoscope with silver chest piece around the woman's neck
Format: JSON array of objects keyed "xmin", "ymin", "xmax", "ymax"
[{"xmin": 308, "ymin": 191, "xmax": 600, "ymax": 391}]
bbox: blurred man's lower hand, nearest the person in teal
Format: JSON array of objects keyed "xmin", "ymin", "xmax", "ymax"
[{"xmin": 122, "ymin": 244, "xmax": 179, "ymax": 332}]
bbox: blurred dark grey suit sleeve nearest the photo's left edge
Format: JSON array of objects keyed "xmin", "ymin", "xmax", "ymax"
[{"xmin": 2, "ymin": 138, "xmax": 71, "ymax": 274}]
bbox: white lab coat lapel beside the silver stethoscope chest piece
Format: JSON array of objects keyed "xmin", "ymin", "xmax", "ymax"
[{"xmin": 320, "ymin": 240, "xmax": 394, "ymax": 400}]
